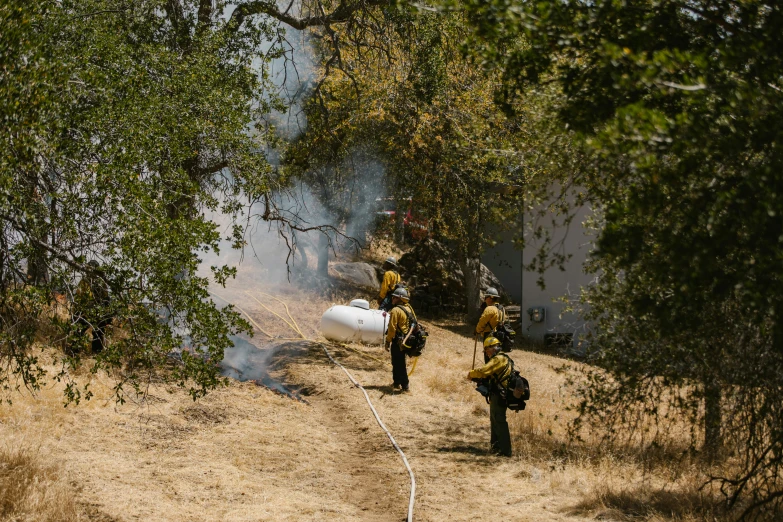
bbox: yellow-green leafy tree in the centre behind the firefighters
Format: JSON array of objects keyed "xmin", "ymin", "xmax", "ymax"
[{"xmin": 286, "ymin": 7, "xmax": 578, "ymax": 315}]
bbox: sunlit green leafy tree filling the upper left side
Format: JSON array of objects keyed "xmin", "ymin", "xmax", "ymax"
[{"xmin": 0, "ymin": 0, "xmax": 288, "ymax": 402}]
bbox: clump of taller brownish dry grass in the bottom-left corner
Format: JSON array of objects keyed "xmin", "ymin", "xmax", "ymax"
[{"xmin": 0, "ymin": 447, "xmax": 81, "ymax": 522}]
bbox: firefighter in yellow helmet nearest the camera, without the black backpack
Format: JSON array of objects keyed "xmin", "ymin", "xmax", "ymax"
[{"xmin": 468, "ymin": 337, "xmax": 512, "ymax": 457}]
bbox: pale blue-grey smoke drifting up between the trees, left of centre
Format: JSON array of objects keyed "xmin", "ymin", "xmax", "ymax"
[{"xmin": 199, "ymin": 17, "xmax": 386, "ymax": 382}]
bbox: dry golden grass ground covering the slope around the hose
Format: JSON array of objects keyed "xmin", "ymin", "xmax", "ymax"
[{"xmin": 0, "ymin": 264, "xmax": 744, "ymax": 522}]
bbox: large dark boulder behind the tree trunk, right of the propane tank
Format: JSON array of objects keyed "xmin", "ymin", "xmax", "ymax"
[{"xmin": 399, "ymin": 239, "xmax": 508, "ymax": 313}]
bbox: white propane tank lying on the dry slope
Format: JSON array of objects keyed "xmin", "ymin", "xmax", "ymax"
[{"xmin": 321, "ymin": 299, "xmax": 389, "ymax": 344}]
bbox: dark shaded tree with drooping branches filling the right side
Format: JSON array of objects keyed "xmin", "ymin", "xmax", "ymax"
[{"xmin": 456, "ymin": 0, "xmax": 783, "ymax": 517}]
